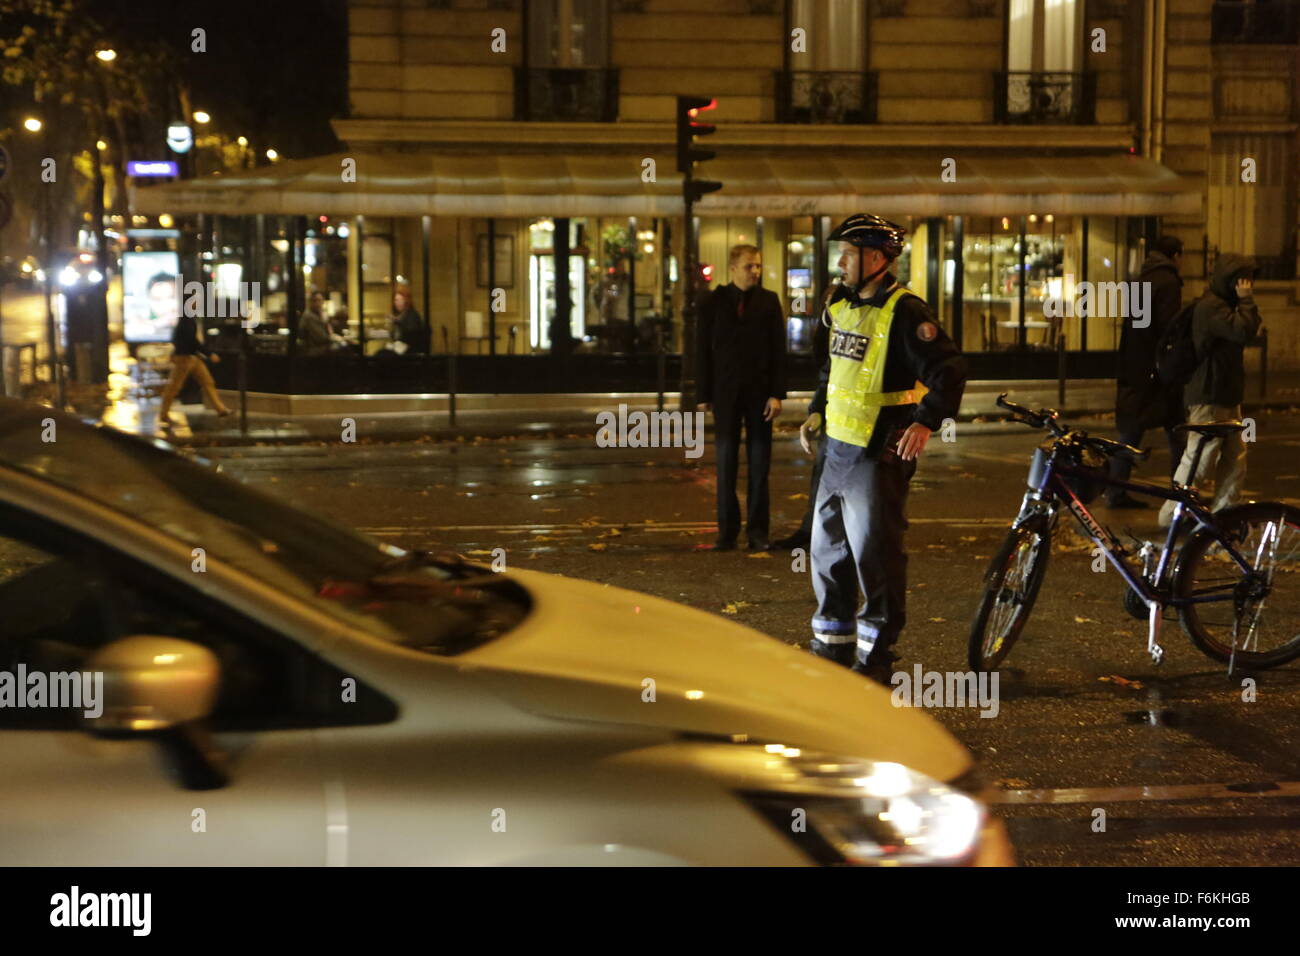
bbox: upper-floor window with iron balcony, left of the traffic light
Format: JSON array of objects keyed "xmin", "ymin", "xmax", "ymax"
[{"xmin": 515, "ymin": 0, "xmax": 619, "ymax": 122}]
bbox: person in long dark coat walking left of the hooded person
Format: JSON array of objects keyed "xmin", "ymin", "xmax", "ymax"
[{"xmin": 1106, "ymin": 235, "xmax": 1186, "ymax": 509}]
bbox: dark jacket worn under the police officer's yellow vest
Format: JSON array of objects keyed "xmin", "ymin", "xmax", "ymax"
[{"xmin": 809, "ymin": 274, "xmax": 966, "ymax": 458}]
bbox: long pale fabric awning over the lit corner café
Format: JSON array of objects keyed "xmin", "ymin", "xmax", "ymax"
[{"xmin": 133, "ymin": 150, "xmax": 1201, "ymax": 217}]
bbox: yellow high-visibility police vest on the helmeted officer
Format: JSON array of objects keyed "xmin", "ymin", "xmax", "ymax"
[{"xmin": 826, "ymin": 285, "xmax": 924, "ymax": 447}]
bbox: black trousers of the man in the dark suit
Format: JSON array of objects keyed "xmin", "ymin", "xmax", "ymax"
[{"xmin": 714, "ymin": 395, "xmax": 772, "ymax": 541}]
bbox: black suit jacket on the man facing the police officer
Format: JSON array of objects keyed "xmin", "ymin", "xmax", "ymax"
[{"xmin": 696, "ymin": 282, "xmax": 785, "ymax": 402}]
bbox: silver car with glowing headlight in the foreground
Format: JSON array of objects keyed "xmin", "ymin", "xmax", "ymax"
[{"xmin": 0, "ymin": 399, "xmax": 1010, "ymax": 866}]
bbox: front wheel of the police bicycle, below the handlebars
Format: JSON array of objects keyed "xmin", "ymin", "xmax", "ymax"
[{"xmin": 967, "ymin": 518, "xmax": 1052, "ymax": 671}]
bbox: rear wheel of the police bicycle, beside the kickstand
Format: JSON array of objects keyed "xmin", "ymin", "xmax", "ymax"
[{"xmin": 1174, "ymin": 502, "xmax": 1300, "ymax": 669}]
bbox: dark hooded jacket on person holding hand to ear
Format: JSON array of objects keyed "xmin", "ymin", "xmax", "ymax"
[{"xmin": 1183, "ymin": 252, "xmax": 1261, "ymax": 405}]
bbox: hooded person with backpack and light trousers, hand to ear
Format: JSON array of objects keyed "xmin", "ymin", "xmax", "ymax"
[{"xmin": 1160, "ymin": 252, "xmax": 1261, "ymax": 528}]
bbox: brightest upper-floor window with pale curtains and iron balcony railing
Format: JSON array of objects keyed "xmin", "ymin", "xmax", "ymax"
[{"xmin": 993, "ymin": 0, "xmax": 1096, "ymax": 124}]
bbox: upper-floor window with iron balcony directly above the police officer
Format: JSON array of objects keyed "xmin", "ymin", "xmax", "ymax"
[{"xmin": 776, "ymin": 0, "xmax": 876, "ymax": 124}]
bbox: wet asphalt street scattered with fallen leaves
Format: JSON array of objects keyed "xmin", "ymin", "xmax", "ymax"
[{"xmin": 189, "ymin": 412, "xmax": 1300, "ymax": 866}]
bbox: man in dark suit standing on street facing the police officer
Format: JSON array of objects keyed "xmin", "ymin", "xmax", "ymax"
[{"xmin": 697, "ymin": 245, "xmax": 785, "ymax": 551}]
